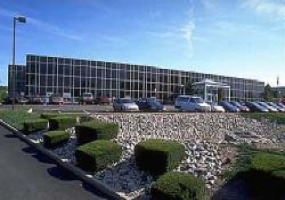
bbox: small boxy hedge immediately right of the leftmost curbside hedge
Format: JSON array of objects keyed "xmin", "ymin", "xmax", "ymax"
[{"xmin": 49, "ymin": 116, "xmax": 77, "ymax": 131}]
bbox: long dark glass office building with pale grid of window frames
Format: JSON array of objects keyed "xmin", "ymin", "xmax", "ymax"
[{"xmin": 9, "ymin": 55, "xmax": 264, "ymax": 100}]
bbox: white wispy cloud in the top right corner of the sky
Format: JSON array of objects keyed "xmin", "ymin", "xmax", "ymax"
[{"xmin": 241, "ymin": 0, "xmax": 285, "ymax": 19}]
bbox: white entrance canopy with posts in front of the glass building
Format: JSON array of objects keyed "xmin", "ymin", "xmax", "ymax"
[{"xmin": 192, "ymin": 79, "xmax": 231, "ymax": 101}]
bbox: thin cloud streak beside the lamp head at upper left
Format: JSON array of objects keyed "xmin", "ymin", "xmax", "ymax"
[{"xmin": 0, "ymin": 8, "xmax": 83, "ymax": 41}]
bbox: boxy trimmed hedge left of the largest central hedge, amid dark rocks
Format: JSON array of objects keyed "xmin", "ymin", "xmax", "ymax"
[{"xmin": 75, "ymin": 140, "xmax": 122, "ymax": 173}]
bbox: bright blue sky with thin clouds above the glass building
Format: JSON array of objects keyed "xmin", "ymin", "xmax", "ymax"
[{"xmin": 0, "ymin": 0, "xmax": 285, "ymax": 86}]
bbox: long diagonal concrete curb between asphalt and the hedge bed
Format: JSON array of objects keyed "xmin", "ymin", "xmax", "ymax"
[{"xmin": 0, "ymin": 119, "xmax": 128, "ymax": 200}]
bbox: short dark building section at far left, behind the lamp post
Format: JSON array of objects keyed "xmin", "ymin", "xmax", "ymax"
[{"xmin": 8, "ymin": 65, "xmax": 26, "ymax": 96}]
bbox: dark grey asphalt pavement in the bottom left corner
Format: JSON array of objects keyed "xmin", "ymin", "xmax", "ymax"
[{"xmin": 0, "ymin": 126, "xmax": 107, "ymax": 200}]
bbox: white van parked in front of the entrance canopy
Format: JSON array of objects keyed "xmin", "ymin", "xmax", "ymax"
[{"xmin": 174, "ymin": 95, "xmax": 211, "ymax": 112}]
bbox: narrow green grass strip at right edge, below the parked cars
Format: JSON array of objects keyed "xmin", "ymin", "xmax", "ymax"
[{"xmin": 241, "ymin": 112, "xmax": 285, "ymax": 124}]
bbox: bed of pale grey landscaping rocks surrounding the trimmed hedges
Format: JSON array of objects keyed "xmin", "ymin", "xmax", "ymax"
[{"xmin": 25, "ymin": 113, "xmax": 285, "ymax": 199}]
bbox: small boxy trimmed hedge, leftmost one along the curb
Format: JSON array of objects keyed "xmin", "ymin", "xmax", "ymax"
[{"xmin": 23, "ymin": 119, "xmax": 48, "ymax": 134}]
